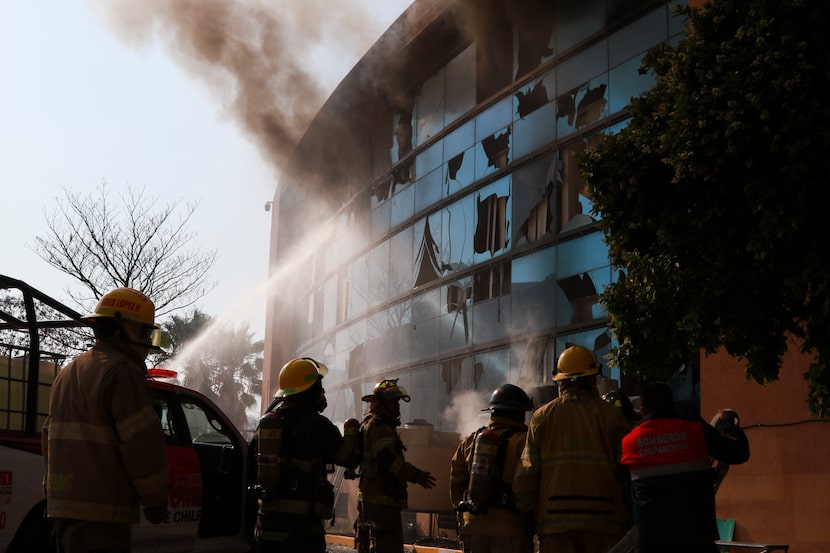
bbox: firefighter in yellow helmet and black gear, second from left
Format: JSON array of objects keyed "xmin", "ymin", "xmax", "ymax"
[{"xmin": 254, "ymin": 357, "xmax": 359, "ymax": 553}]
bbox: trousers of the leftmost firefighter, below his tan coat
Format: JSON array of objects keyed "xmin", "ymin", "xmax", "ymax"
[{"xmin": 53, "ymin": 518, "xmax": 132, "ymax": 553}]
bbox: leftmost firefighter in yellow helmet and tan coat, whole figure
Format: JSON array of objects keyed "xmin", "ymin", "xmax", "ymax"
[{"xmin": 42, "ymin": 288, "xmax": 168, "ymax": 553}]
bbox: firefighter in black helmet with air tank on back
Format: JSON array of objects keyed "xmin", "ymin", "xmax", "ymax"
[{"xmin": 450, "ymin": 384, "xmax": 533, "ymax": 553}]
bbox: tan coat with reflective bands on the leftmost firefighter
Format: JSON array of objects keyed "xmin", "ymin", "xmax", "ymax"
[{"xmin": 42, "ymin": 340, "xmax": 168, "ymax": 524}]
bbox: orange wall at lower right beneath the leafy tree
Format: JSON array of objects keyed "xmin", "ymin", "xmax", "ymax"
[{"xmin": 700, "ymin": 344, "xmax": 830, "ymax": 553}]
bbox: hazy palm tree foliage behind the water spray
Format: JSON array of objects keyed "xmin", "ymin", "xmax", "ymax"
[{"xmin": 153, "ymin": 309, "xmax": 264, "ymax": 431}]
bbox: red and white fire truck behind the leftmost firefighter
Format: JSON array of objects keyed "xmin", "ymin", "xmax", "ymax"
[{"xmin": 0, "ymin": 275, "xmax": 256, "ymax": 553}]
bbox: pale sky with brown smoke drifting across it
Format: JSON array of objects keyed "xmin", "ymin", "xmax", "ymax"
[{"xmin": 0, "ymin": 0, "xmax": 410, "ymax": 339}]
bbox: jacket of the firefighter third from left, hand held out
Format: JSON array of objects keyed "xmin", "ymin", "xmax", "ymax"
[{"xmin": 357, "ymin": 412, "xmax": 421, "ymax": 509}]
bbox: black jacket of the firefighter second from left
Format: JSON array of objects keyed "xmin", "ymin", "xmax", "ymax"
[{"xmin": 257, "ymin": 399, "xmax": 352, "ymax": 516}]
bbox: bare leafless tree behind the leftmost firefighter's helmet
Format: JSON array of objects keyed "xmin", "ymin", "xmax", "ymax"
[{"xmin": 34, "ymin": 181, "xmax": 216, "ymax": 318}]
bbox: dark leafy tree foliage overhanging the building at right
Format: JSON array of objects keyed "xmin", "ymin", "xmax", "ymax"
[{"xmin": 582, "ymin": 0, "xmax": 830, "ymax": 417}]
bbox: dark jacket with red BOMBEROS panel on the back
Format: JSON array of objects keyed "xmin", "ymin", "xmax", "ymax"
[{"xmin": 622, "ymin": 414, "xmax": 749, "ymax": 551}]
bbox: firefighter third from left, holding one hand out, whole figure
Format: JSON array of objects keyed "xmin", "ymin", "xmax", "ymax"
[{"xmin": 355, "ymin": 379, "xmax": 435, "ymax": 553}]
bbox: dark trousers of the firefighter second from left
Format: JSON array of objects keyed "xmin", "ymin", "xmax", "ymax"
[{"xmin": 255, "ymin": 513, "xmax": 326, "ymax": 553}]
